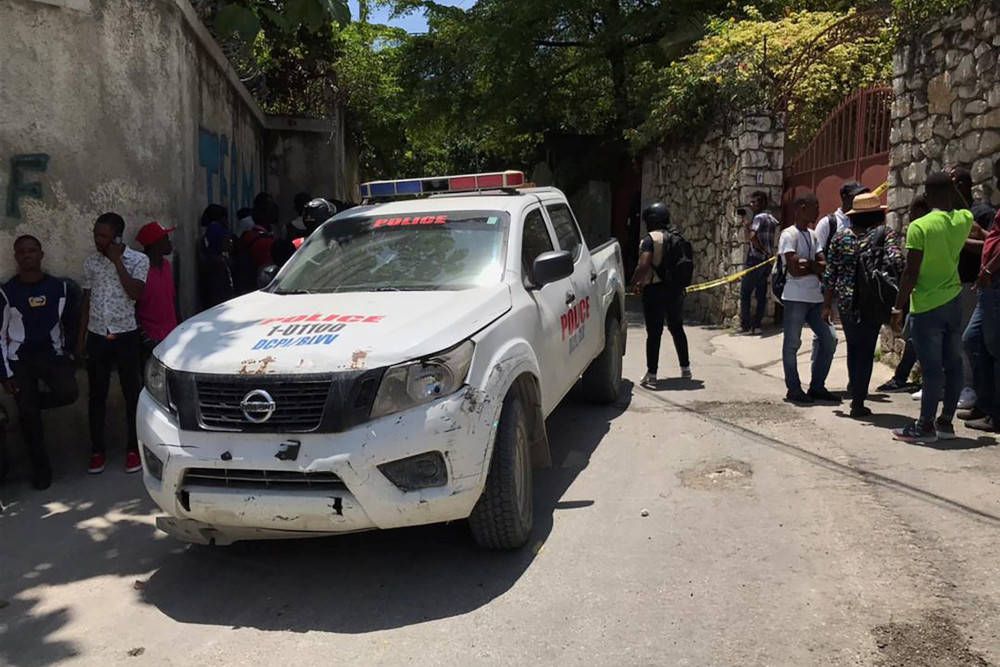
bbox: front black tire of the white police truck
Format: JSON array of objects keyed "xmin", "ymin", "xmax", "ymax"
[{"xmin": 469, "ymin": 390, "xmax": 534, "ymax": 549}]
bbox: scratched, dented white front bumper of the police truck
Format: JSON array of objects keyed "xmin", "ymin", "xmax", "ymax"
[{"xmin": 137, "ymin": 387, "xmax": 496, "ymax": 544}]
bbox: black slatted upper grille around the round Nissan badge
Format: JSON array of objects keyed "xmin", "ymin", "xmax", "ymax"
[{"xmin": 196, "ymin": 377, "xmax": 330, "ymax": 433}]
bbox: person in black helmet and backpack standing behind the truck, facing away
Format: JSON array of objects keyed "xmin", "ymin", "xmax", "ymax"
[{"xmin": 634, "ymin": 202, "xmax": 694, "ymax": 388}]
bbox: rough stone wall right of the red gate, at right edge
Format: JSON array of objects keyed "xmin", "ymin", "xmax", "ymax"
[{"xmin": 883, "ymin": 1, "xmax": 1000, "ymax": 363}]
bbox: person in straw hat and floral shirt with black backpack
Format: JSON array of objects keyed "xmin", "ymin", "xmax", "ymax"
[{"xmin": 823, "ymin": 193, "xmax": 903, "ymax": 419}]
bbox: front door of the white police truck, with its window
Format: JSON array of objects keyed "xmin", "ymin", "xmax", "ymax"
[{"xmin": 521, "ymin": 206, "xmax": 576, "ymax": 414}]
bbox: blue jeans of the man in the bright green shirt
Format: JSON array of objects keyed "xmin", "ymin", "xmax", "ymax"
[{"xmin": 910, "ymin": 295, "xmax": 963, "ymax": 426}]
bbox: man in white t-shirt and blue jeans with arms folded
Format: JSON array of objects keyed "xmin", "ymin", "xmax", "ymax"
[{"xmin": 778, "ymin": 194, "xmax": 840, "ymax": 404}]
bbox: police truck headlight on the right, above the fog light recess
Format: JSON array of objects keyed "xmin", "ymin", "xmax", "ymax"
[{"xmin": 372, "ymin": 340, "xmax": 475, "ymax": 419}]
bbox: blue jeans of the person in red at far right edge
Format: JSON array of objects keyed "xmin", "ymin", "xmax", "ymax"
[{"xmin": 962, "ymin": 284, "xmax": 1000, "ymax": 420}]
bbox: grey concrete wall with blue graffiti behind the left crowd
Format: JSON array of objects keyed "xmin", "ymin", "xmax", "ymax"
[{"xmin": 0, "ymin": 0, "xmax": 354, "ymax": 314}]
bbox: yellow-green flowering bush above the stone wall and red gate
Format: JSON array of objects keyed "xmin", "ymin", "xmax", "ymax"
[{"xmin": 630, "ymin": 7, "xmax": 892, "ymax": 147}]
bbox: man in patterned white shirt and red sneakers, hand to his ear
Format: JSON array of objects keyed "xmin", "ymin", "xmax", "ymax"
[{"xmin": 77, "ymin": 213, "xmax": 149, "ymax": 474}]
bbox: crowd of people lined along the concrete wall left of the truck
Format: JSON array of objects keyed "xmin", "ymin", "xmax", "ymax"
[{"xmin": 0, "ymin": 193, "xmax": 349, "ymax": 490}]
